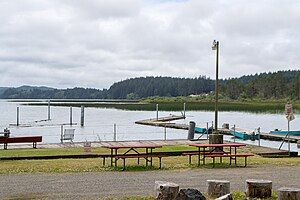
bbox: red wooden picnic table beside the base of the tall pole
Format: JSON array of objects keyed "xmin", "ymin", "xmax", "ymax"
[{"xmin": 189, "ymin": 143, "xmax": 248, "ymax": 166}]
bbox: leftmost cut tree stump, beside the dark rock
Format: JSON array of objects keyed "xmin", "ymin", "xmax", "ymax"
[{"xmin": 155, "ymin": 181, "xmax": 179, "ymax": 200}]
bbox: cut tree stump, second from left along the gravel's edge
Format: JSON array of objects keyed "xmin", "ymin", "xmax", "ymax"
[{"xmin": 207, "ymin": 180, "xmax": 230, "ymax": 198}]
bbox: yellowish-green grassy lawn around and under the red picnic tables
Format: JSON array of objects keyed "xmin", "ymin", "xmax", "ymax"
[{"xmin": 0, "ymin": 145, "xmax": 300, "ymax": 174}]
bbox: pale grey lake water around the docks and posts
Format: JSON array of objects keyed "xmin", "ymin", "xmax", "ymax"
[{"xmin": 0, "ymin": 100, "xmax": 300, "ymax": 150}]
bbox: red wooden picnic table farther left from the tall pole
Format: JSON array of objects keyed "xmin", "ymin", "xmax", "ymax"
[{"xmin": 103, "ymin": 143, "xmax": 162, "ymax": 167}]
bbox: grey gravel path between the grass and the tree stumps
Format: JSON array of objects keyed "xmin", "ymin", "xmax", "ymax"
[{"xmin": 0, "ymin": 166, "xmax": 300, "ymax": 199}]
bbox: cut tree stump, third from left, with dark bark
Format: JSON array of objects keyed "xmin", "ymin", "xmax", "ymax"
[{"xmin": 246, "ymin": 179, "xmax": 272, "ymax": 198}]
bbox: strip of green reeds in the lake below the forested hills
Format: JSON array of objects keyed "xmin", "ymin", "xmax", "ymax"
[{"xmin": 24, "ymin": 98, "xmax": 300, "ymax": 113}]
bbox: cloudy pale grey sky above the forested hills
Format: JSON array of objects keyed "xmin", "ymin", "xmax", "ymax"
[{"xmin": 0, "ymin": 0, "xmax": 300, "ymax": 89}]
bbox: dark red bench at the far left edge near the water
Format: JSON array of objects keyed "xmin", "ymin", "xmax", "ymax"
[{"xmin": 0, "ymin": 136, "xmax": 42, "ymax": 149}]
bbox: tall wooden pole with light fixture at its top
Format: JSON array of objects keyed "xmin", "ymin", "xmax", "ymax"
[{"xmin": 212, "ymin": 40, "xmax": 219, "ymax": 133}]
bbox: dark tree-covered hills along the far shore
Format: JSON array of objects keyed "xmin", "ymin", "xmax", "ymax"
[{"xmin": 0, "ymin": 70, "xmax": 300, "ymax": 99}]
